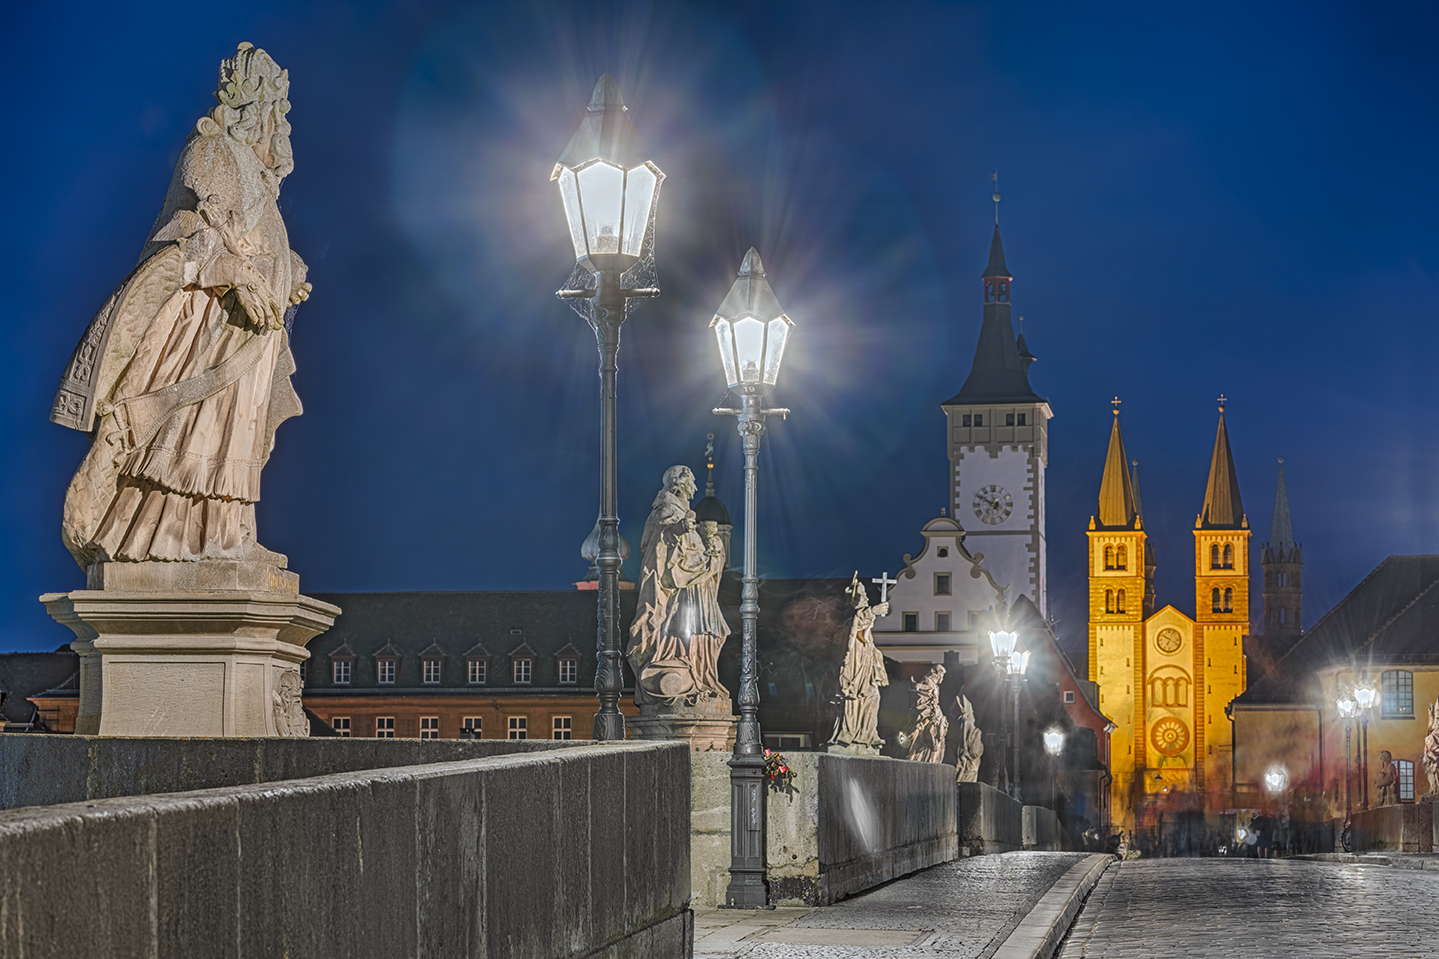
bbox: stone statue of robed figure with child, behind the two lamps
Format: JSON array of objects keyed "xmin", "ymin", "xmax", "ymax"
[{"xmin": 626, "ymin": 467, "xmax": 731, "ymax": 705}]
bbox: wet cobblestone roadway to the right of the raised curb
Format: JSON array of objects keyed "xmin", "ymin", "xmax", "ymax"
[{"xmin": 1059, "ymin": 860, "xmax": 1439, "ymax": 959}]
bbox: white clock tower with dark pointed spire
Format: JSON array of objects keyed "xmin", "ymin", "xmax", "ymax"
[{"xmin": 943, "ymin": 215, "xmax": 1053, "ymax": 615}]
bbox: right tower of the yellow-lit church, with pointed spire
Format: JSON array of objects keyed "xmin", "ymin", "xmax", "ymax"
[{"xmin": 1194, "ymin": 396, "xmax": 1249, "ymax": 791}]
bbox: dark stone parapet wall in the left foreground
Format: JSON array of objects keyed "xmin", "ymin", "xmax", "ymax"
[{"xmin": 0, "ymin": 736, "xmax": 694, "ymax": 959}]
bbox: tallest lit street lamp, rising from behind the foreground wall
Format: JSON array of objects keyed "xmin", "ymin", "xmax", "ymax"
[{"xmin": 550, "ymin": 73, "xmax": 665, "ymax": 740}]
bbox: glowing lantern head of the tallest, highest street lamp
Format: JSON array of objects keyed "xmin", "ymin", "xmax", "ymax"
[{"xmin": 550, "ymin": 73, "xmax": 665, "ymax": 272}]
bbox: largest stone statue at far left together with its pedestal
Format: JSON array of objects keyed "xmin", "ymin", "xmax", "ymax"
[{"xmin": 40, "ymin": 43, "xmax": 340, "ymax": 736}]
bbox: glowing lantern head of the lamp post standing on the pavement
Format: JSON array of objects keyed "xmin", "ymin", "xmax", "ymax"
[{"xmin": 709, "ymin": 246, "xmax": 794, "ymax": 393}]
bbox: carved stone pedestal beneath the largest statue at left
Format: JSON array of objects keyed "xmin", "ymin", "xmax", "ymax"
[{"xmin": 40, "ymin": 560, "xmax": 340, "ymax": 736}]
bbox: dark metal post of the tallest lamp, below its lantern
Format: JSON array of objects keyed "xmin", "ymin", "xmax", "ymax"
[{"xmin": 591, "ymin": 269, "xmax": 626, "ymax": 740}]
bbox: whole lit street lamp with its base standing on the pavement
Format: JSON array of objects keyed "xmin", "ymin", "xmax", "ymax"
[{"xmin": 709, "ymin": 246, "xmax": 794, "ymax": 909}]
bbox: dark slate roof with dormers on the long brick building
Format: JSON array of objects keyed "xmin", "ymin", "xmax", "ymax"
[{"xmin": 305, "ymin": 589, "xmax": 636, "ymax": 695}]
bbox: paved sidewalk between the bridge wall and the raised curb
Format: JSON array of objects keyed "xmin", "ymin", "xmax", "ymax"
[{"xmin": 695, "ymin": 852, "xmax": 1085, "ymax": 959}]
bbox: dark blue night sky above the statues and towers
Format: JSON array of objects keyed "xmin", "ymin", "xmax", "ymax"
[{"xmin": 0, "ymin": 1, "xmax": 1439, "ymax": 649}]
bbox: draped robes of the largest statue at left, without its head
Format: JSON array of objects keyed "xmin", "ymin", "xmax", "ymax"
[{"xmin": 52, "ymin": 124, "xmax": 305, "ymax": 566}]
